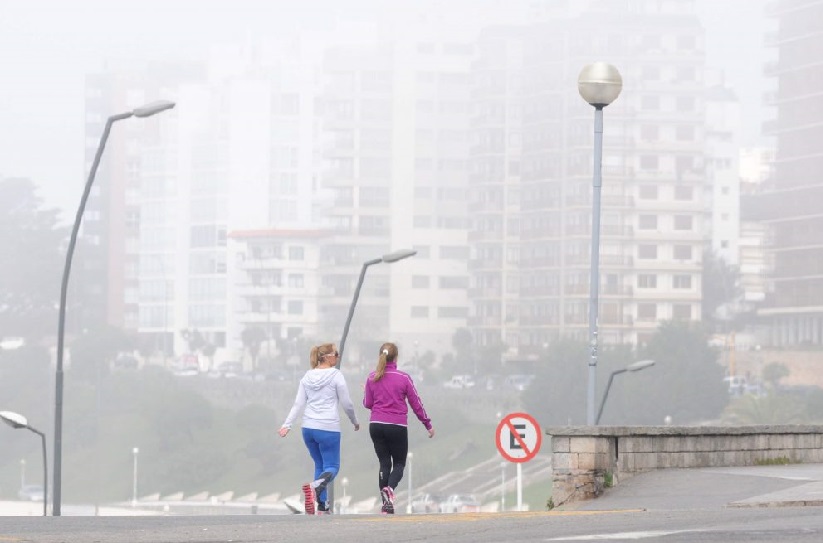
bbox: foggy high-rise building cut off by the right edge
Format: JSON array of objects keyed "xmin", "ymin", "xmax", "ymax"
[{"xmin": 748, "ymin": 0, "xmax": 823, "ymax": 346}]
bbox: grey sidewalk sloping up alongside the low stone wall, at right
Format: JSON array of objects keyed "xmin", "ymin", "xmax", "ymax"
[{"xmin": 558, "ymin": 464, "xmax": 823, "ymax": 511}]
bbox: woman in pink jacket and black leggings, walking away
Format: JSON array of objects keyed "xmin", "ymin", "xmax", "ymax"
[{"xmin": 363, "ymin": 343, "xmax": 434, "ymax": 515}]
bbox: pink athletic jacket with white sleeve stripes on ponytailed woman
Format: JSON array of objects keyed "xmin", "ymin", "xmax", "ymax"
[{"xmin": 363, "ymin": 362, "xmax": 432, "ymax": 430}]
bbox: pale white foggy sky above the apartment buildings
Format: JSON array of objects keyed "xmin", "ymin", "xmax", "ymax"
[{"xmin": 0, "ymin": 0, "xmax": 768, "ymax": 221}]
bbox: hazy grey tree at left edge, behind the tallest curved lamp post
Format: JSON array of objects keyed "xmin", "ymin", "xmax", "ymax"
[{"xmin": 0, "ymin": 178, "xmax": 66, "ymax": 340}]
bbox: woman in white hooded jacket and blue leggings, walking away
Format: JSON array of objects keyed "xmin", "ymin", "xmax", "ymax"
[{"xmin": 279, "ymin": 343, "xmax": 360, "ymax": 515}]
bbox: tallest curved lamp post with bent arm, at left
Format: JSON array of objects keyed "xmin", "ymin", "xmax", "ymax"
[{"xmin": 51, "ymin": 100, "xmax": 175, "ymax": 517}]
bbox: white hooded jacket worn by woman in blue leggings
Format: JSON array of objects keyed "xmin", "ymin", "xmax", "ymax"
[{"xmin": 283, "ymin": 368, "xmax": 359, "ymax": 432}]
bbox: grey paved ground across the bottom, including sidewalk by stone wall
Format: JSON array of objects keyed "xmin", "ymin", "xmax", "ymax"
[{"xmin": 0, "ymin": 465, "xmax": 823, "ymax": 543}]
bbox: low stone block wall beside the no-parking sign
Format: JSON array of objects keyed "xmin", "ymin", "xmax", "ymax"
[{"xmin": 545, "ymin": 425, "xmax": 823, "ymax": 507}]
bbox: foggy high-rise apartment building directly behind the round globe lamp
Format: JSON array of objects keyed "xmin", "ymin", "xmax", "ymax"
[{"xmin": 469, "ymin": 0, "xmax": 708, "ymax": 353}]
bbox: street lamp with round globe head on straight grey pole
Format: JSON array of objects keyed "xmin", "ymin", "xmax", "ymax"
[{"xmin": 577, "ymin": 62, "xmax": 623, "ymax": 425}]
